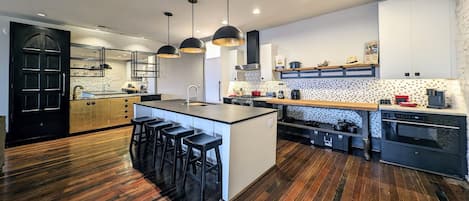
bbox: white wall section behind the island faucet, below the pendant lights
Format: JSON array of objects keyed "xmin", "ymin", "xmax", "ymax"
[{"xmin": 157, "ymin": 54, "xmax": 204, "ymax": 101}]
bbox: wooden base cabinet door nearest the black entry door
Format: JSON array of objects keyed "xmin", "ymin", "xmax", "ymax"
[{"xmin": 70, "ymin": 100, "xmax": 93, "ymax": 133}]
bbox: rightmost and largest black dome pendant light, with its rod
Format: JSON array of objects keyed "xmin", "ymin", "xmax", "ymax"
[{"xmin": 212, "ymin": 0, "xmax": 244, "ymax": 47}]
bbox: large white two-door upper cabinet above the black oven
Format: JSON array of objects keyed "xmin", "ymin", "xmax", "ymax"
[{"xmin": 379, "ymin": 0, "xmax": 455, "ymax": 79}]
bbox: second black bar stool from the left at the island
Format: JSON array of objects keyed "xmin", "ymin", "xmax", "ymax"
[{"xmin": 145, "ymin": 119, "xmax": 175, "ymax": 167}]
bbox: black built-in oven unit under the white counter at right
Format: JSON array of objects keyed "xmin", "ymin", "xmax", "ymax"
[{"xmin": 381, "ymin": 111, "xmax": 467, "ymax": 178}]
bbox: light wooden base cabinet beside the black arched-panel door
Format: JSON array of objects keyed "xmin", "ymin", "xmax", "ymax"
[{"xmin": 70, "ymin": 96, "xmax": 140, "ymax": 133}]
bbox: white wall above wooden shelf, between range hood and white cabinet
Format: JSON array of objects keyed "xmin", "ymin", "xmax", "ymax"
[{"xmin": 260, "ymin": 3, "xmax": 378, "ymax": 67}]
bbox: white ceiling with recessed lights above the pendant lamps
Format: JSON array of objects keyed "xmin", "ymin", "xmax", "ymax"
[{"xmin": 0, "ymin": 0, "xmax": 375, "ymax": 43}]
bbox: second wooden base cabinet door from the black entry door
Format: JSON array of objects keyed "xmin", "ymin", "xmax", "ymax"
[{"xmin": 91, "ymin": 99, "xmax": 110, "ymax": 129}]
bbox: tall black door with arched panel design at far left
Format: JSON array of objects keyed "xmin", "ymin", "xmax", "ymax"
[{"xmin": 7, "ymin": 22, "xmax": 70, "ymax": 146}]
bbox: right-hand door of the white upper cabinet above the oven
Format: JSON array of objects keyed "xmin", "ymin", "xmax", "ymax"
[{"xmin": 411, "ymin": 0, "xmax": 454, "ymax": 78}]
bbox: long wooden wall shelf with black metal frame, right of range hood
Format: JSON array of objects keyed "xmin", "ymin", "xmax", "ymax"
[{"xmin": 274, "ymin": 64, "xmax": 379, "ymax": 79}]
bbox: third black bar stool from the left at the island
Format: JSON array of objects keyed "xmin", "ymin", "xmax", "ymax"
[{"xmin": 160, "ymin": 126, "xmax": 194, "ymax": 184}]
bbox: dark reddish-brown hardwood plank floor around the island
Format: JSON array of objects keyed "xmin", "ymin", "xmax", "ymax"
[{"xmin": 0, "ymin": 127, "xmax": 469, "ymax": 201}]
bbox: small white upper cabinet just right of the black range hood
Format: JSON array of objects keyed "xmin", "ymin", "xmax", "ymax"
[{"xmin": 259, "ymin": 43, "xmax": 278, "ymax": 81}]
